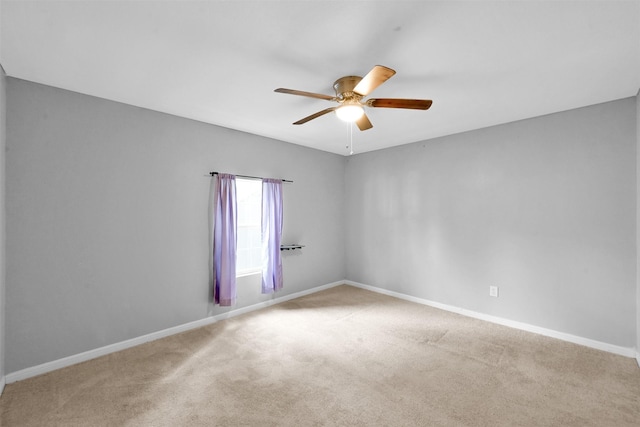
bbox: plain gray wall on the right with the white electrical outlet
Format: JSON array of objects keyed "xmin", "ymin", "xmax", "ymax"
[{"xmin": 346, "ymin": 97, "xmax": 636, "ymax": 348}]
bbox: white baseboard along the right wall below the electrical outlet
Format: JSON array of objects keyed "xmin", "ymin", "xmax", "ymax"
[{"xmin": 344, "ymin": 280, "xmax": 640, "ymax": 365}]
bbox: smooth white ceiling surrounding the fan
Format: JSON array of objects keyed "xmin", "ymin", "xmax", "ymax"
[{"xmin": 0, "ymin": 0, "xmax": 640, "ymax": 155}]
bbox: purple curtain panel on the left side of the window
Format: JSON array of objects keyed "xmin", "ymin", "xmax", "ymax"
[{"xmin": 212, "ymin": 173, "xmax": 238, "ymax": 306}]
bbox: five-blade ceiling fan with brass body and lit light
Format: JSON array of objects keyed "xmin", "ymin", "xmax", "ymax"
[{"xmin": 275, "ymin": 65, "xmax": 432, "ymax": 130}]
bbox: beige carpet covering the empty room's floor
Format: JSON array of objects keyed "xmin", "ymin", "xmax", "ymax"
[{"xmin": 0, "ymin": 286, "xmax": 640, "ymax": 426}]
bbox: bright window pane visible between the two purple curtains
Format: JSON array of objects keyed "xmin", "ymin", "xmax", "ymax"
[{"xmin": 236, "ymin": 178, "xmax": 262, "ymax": 276}]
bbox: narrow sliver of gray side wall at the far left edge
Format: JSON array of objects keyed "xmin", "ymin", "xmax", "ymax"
[{"xmin": 0, "ymin": 65, "xmax": 7, "ymax": 386}]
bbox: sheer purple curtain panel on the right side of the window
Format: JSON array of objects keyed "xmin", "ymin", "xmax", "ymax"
[{"xmin": 262, "ymin": 179, "xmax": 282, "ymax": 294}]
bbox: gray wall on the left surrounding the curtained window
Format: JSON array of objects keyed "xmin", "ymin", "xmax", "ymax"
[{"xmin": 6, "ymin": 78, "xmax": 345, "ymax": 372}]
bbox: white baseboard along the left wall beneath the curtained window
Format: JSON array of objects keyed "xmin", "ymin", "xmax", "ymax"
[{"xmin": 6, "ymin": 280, "xmax": 345, "ymax": 387}]
